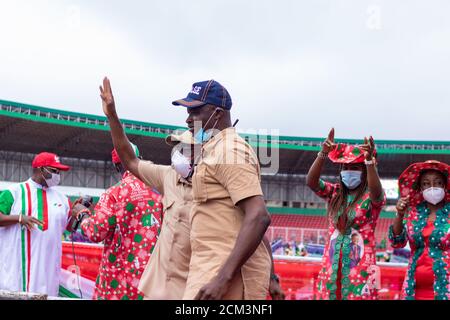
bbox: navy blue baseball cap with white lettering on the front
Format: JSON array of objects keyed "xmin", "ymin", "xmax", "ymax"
[{"xmin": 172, "ymin": 80, "xmax": 233, "ymax": 110}]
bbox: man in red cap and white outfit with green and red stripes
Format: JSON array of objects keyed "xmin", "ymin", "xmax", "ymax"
[{"xmin": 0, "ymin": 152, "xmax": 76, "ymax": 296}]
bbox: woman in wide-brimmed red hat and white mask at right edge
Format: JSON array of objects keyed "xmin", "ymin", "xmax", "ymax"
[{"xmin": 389, "ymin": 160, "xmax": 450, "ymax": 300}]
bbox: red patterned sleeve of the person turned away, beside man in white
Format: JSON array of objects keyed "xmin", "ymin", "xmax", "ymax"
[{"xmin": 81, "ymin": 192, "xmax": 116, "ymax": 242}]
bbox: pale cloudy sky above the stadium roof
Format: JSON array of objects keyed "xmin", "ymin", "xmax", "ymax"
[{"xmin": 0, "ymin": 0, "xmax": 450, "ymax": 140}]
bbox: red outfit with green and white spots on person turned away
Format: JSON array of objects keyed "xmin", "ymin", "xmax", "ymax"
[{"xmin": 81, "ymin": 171, "xmax": 162, "ymax": 300}]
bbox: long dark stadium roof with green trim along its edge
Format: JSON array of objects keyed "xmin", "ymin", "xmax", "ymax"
[{"xmin": 0, "ymin": 100, "xmax": 450, "ymax": 177}]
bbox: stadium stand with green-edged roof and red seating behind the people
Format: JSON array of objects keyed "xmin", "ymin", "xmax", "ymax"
[{"xmin": 0, "ymin": 100, "xmax": 450, "ymax": 250}]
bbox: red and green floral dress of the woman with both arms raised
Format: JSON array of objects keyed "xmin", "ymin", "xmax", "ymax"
[{"xmin": 314, "ymin": 180, "xmax": 386, "ymax": 300}]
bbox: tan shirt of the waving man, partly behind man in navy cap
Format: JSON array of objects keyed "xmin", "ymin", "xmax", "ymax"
[{"xmin": 135, "ymin": 161, "xmax": 192, "ymax": 300}]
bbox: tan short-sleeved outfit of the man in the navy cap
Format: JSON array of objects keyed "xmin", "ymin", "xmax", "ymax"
[{"xmin": 183, "ymin": 128, "xmax": 271, "ymax": 299}]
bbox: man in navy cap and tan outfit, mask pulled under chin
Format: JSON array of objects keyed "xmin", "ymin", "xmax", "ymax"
[{"xmin": 173, "ymin": 80, "xmax": 271, "ymax": 300}]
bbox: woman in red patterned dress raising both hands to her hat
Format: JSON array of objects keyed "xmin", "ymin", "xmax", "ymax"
[{"xmin": 307, "ymin": 129, "xmax": 386, "ymax": 300}]
